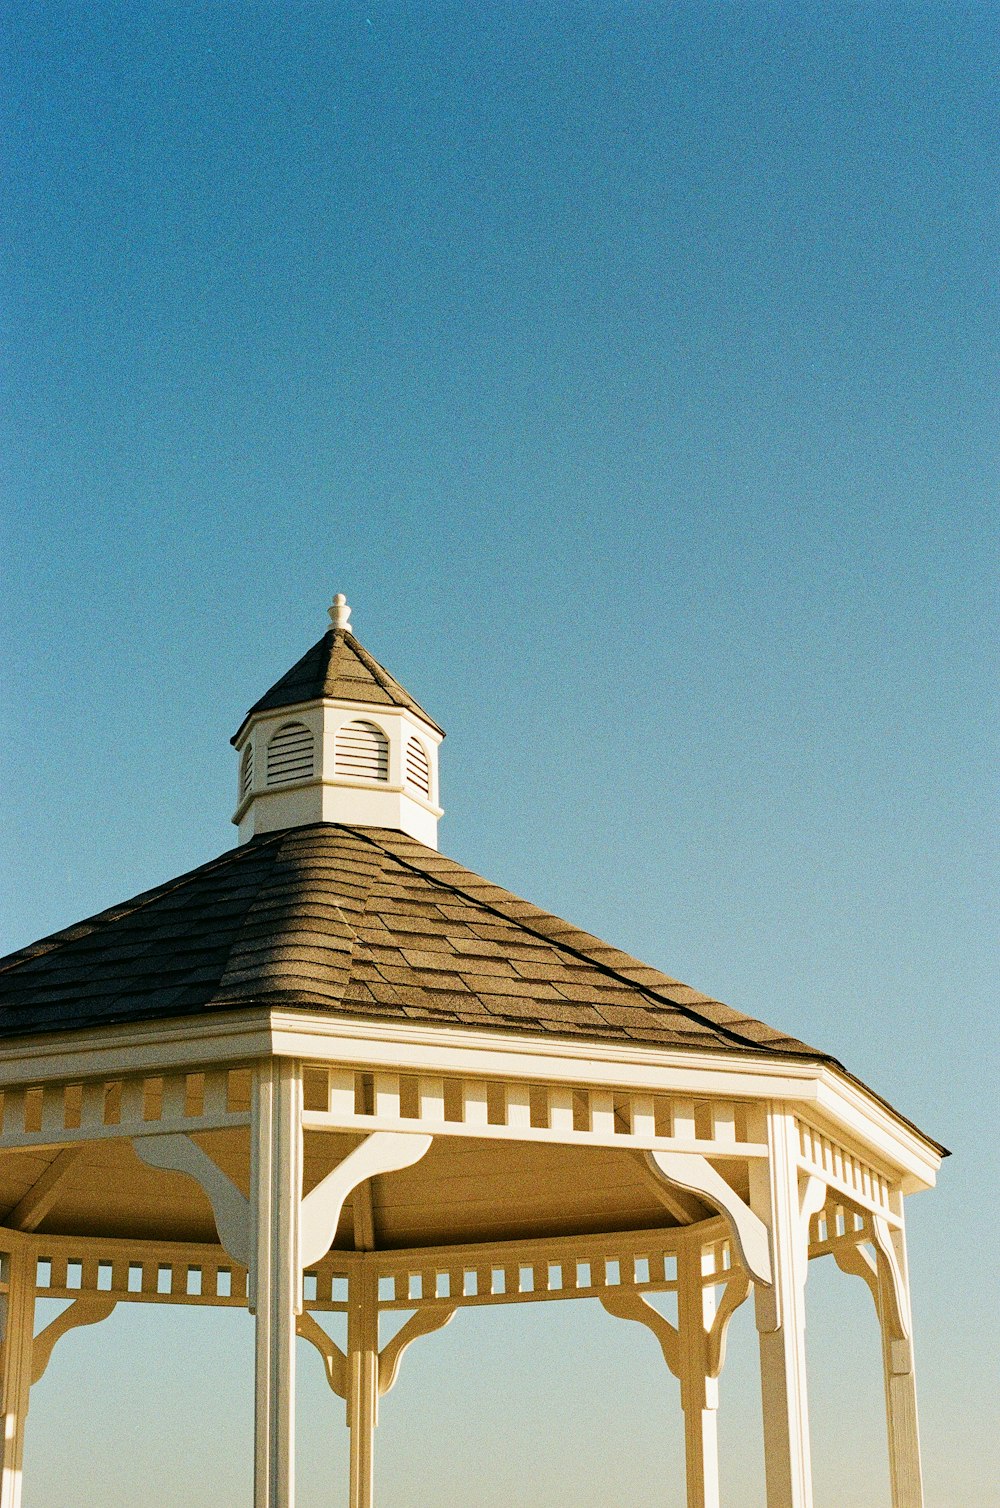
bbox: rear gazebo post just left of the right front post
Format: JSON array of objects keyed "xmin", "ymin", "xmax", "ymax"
[{"xmin": 677, "ymin": 1241, "xmax": 719, "ymax": 1508}]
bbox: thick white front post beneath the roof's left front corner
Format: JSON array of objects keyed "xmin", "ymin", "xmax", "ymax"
[{"xmin": 250, "ymin": 1059, "xmax": 302, "ymax": 1508}]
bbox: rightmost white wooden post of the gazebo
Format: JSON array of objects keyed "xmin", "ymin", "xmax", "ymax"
[{"xmin": 878, "ymin": 1196, "xmax": 923, "ymax": 1508}]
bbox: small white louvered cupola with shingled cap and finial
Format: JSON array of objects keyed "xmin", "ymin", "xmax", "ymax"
[{"xmin": 232, "ymin": 593, "xmax": 445, "ymax": 847}]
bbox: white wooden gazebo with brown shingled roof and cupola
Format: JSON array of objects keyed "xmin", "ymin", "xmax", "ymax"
[{"xmin": 0, "ymin": 596, "xmax": 944, "ymax": 1508}]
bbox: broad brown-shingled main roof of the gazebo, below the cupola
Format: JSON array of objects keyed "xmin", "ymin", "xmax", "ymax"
[{"xmin": 0, "ymin": 823, "xmax": 836, "ymax": 1063}]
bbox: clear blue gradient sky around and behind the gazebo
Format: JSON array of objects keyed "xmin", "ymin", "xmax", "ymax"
[{"xmin": 0, "ymin": 0, "xmax": 1000, "ymax": 1508}]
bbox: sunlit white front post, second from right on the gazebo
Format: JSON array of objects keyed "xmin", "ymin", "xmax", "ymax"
[{"xmin": 750, "ymin": 1105, "xmax": 813, "ymax": 1508}]
